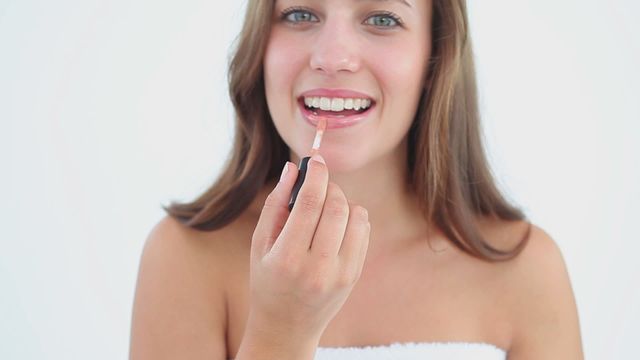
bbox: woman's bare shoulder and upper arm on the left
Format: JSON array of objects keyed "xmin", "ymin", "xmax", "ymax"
[{"xmin": 130, "ymin": 217, "xmax": 236, "ymax": 359}]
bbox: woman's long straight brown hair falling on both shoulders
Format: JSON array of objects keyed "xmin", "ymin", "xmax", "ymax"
[{"xmin": 163, "ymin": 0, "xmax": 531, "ymax": 261}]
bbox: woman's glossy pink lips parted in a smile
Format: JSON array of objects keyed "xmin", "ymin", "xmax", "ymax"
[{"xmin": 298, "ymin": 89, "xmax": 375, "ymax": 129}]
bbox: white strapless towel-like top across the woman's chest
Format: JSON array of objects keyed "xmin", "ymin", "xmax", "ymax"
[{"xmin": 314, "ymin": 342, "xmax": 507, "ymax": 360}]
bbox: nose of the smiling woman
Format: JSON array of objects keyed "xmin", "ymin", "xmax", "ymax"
[{"xmin": 309, "ymin": 20, "xmax": 361, "ymax": 76}]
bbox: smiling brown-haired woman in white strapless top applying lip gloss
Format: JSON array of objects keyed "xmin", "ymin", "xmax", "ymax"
[{"xmin": 131, "ymin": 0, "xmax": 582, "ymax": 360}]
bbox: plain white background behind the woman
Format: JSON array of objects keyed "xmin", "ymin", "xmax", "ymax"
[{"xmin": 0, "ymin": 0, "xmax": 640, "ymax": 359}]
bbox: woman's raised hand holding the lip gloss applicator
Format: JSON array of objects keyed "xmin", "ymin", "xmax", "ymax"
[{"xmin": 247, "ymin": 156, "xmax": 371, "ymax": 341}]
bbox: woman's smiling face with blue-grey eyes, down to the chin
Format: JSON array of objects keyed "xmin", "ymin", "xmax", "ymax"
[{"xmin": 264, "ymin": 0, "xmax": 432, "ymax": 171}]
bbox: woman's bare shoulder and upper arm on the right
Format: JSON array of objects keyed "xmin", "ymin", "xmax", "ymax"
[{"xmin": 503, "ymin": 224, "xmax": 584, "ymax": 360}]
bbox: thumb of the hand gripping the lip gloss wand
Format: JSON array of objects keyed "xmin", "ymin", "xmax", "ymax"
[{"xmin": 251, "ymin": 161, "xmax": 298, "ymax": 258}]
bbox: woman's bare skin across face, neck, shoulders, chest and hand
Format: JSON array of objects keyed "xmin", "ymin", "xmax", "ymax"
[{"xmin": 131, "ymin": 0, "xmax": 583, "ymax": 360}]
